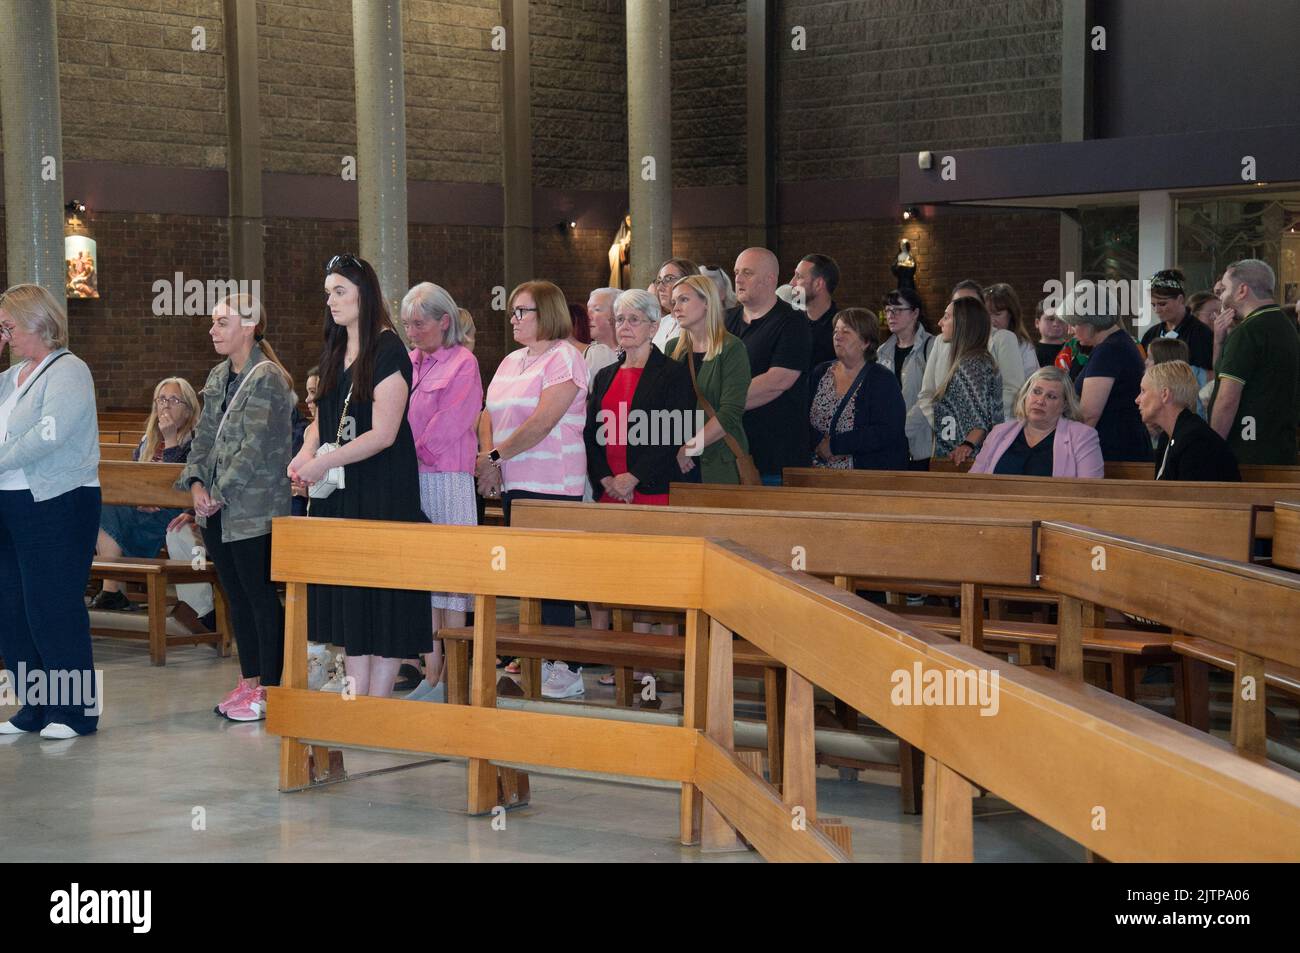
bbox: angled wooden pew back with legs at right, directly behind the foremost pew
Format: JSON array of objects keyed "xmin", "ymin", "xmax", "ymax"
[{"xmin": 1039, "ymin": 523, "xmax": 1300, "ymax": 758}]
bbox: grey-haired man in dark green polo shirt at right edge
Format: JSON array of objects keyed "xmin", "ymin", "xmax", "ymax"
[{"xmin": 1210, "ymin": 259, "xmax": 1300, "ymax": 465}]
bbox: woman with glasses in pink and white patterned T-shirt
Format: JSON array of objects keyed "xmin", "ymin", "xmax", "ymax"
[{"xmin": 477, "ymin": 281, "xmax": 588, "ymax": 698}]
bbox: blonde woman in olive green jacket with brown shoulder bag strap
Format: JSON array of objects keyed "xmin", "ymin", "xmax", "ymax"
[{"xmin": 664, "ymin": 274, "xmax": 750, "ymax": 484}]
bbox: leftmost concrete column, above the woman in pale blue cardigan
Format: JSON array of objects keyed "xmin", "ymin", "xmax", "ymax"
[{"xmin": 0, "ymin": 0, "xmax": 68, "ymax": 302}]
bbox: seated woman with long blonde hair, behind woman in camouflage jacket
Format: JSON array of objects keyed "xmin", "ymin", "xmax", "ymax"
[{"xmin": 90, "ymin": 377, "xmax": 199, "ymax": 608}]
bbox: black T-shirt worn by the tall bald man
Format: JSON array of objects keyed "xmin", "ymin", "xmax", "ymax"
[{"xmin": 727, "ymin": 298, "xmax": 813, "ymax": 475}]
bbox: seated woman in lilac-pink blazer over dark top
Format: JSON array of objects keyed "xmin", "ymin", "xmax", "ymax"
[{"xmin": 971, "ymin": 367, "xmax": 1105, "ymax": 477}]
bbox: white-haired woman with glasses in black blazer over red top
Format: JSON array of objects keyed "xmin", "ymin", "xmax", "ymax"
[{"xmin": 582, "ymin": 291, "xmax": 696, "ymax": 506}]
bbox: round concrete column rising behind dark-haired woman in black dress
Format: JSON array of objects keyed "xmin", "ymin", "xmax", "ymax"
[{"xmin": 352, "ymin": 0, "xmax": 410, "ymax": 323}]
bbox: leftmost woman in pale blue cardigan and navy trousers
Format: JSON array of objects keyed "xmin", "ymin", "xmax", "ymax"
[{"xmin": 0, "ymin": 285, "xmax": 100, "ymax": 738}]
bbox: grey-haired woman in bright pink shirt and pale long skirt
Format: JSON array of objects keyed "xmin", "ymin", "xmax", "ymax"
[{"xmin": 402, "ymin": 282, "xmax": 484, "ymax": 701}]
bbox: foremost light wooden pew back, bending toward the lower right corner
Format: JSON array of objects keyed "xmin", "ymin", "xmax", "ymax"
[{"xmin": 268, "ymin": 519, "xmax": 1300, "ymax": 861}]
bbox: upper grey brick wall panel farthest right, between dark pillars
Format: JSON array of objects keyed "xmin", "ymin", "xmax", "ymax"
[{"xmin": 777, "ymin": 0, "xmax": 1061, "ymax": 181}]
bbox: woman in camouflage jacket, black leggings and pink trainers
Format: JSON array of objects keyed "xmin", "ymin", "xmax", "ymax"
[{"xmin": 176, "ymin": 295, "xmax": 298, "ymax": 722}]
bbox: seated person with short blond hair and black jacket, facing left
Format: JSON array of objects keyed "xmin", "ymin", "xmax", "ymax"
[{"xmin": 1136, "ymin": 360, "xmax": 1242, "ymax": 482}]
